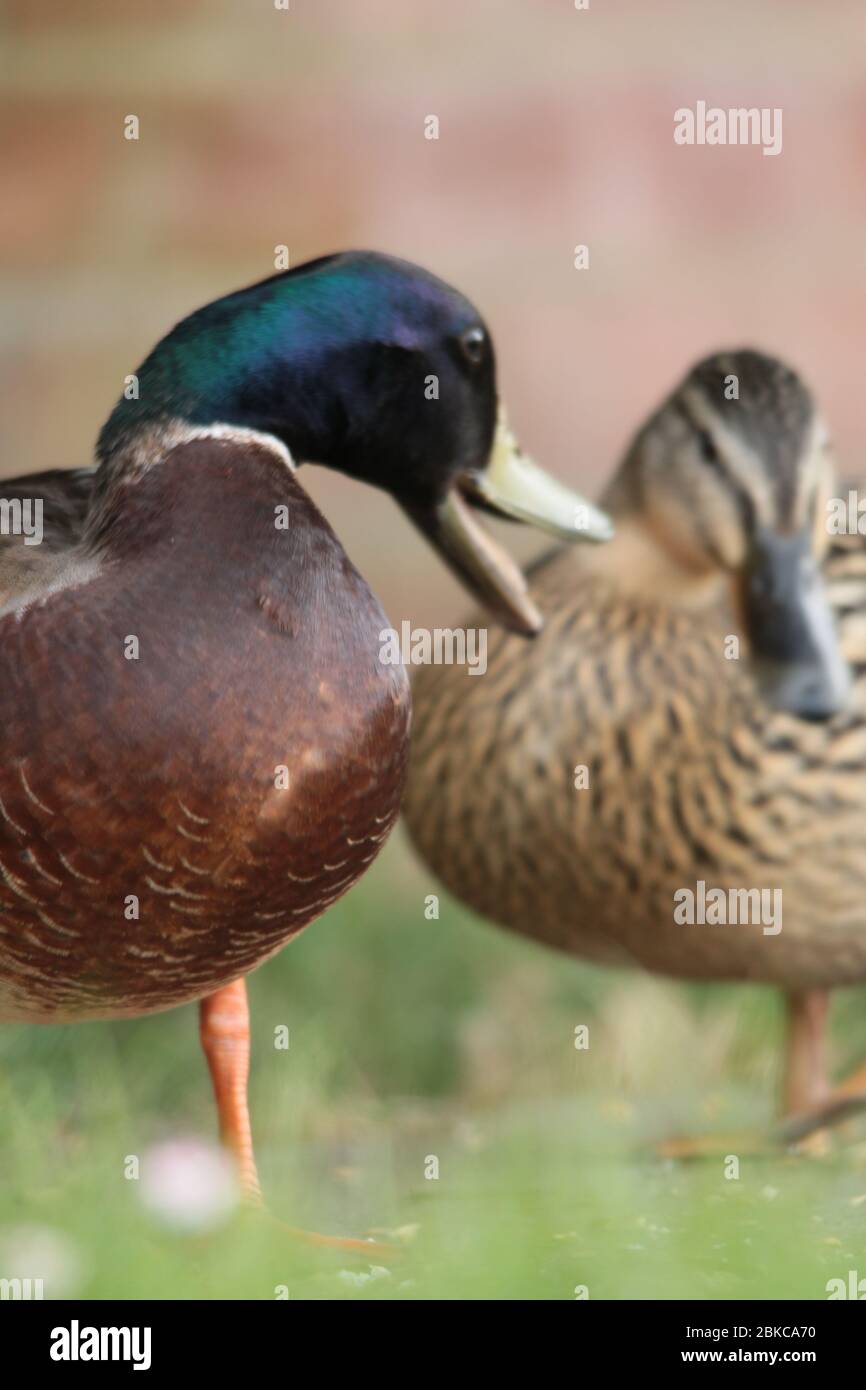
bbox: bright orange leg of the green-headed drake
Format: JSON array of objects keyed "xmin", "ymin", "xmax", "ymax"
[{"xmin": 199, "ymin": 980, "xmax": 261, "ymax": 1205}]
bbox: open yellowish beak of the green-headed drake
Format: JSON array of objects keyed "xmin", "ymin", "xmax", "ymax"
[{"xmin": 410, "ymin": 410, "xmax": 613, "ymax": 637}]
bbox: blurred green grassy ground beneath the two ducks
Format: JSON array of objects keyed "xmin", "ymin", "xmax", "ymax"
[{"xmin": 0, "ymin": 817, "xmax": 866, "ymax": 1298}]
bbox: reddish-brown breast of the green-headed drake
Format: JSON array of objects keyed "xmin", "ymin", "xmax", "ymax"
[{"xmin": 0, "ymin": 441, "xmax": 409, "ymax": 1022}]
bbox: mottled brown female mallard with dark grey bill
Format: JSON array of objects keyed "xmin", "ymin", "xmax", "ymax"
[{"xmin": 406, "ymin": 352, "xmax": 866, "ymax": 1133}]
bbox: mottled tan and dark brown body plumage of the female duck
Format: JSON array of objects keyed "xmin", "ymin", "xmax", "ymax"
[{"xmin": 406, "ymin": 525, "xmax": 866, "ymax": 984}]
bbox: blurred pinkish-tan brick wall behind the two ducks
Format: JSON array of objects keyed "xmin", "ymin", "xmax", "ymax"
[{"xmin": 0, "ymin": 0, "xmax": 866, "ymax": 621}]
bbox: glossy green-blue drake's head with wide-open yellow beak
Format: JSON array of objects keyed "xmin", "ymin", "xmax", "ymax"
[{"xmin": 99, "ymin": 252, "xmax": 610, "ymax": 632}]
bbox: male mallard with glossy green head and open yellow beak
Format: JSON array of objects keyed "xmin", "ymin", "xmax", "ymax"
[{"xmin": 0, "ymin": 253, "xmax": 606, "ymax": 1228}]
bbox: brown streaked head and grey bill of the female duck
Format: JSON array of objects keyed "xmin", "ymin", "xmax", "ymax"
[{"xmin": 605, "ymin": 350, "xmax": 851, "ymax": 720}]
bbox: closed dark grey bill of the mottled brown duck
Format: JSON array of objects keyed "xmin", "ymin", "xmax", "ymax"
[{"xmin": 744, "ymin": 531, "xmax": 851, "ymax": 720}]
